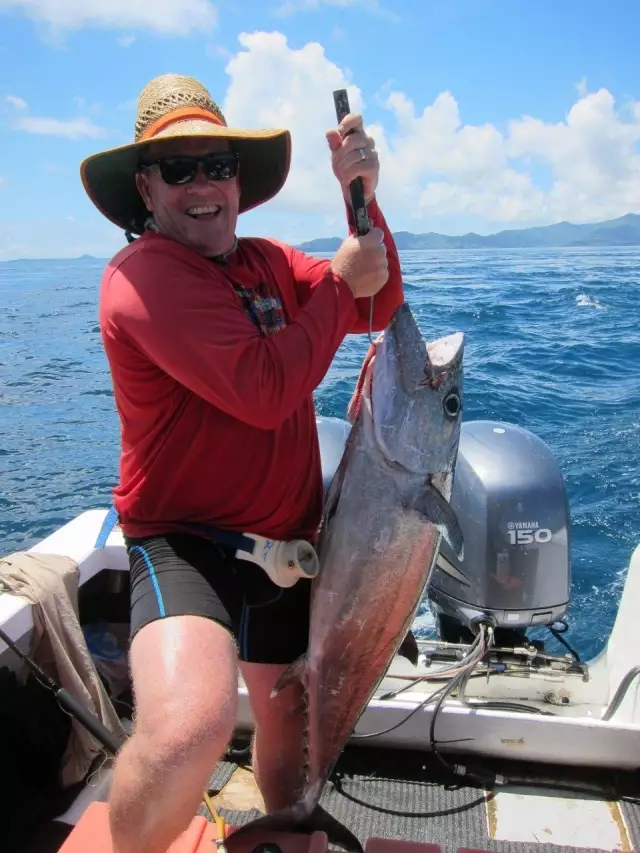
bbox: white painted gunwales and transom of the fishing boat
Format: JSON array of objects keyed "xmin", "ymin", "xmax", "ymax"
[{"xmin": 0, "ymin": 510, "xmax": 640, "ymax": 769}]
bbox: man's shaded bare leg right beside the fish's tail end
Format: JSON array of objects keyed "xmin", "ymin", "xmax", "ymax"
[{"xmin": 240, "ymin": 662, "xmax": 304, "ymax": 812}]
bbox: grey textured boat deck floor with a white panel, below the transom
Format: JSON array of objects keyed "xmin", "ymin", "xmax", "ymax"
[{"xmin": 13, "ymin": 732, "xmax": 640, "ymax": 853}]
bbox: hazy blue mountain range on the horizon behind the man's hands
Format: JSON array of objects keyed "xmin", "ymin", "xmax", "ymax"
[{"xmin": 298, "ymin": 213, "xmax": 640, "ymax": 252}]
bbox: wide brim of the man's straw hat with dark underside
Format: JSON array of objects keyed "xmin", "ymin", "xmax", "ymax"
[{"xmin": 80, "ymin": 120, "xmax": 291, "ymax": 234}]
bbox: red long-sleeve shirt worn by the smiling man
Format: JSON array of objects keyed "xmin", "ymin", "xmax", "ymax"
[{"xmin": 100, "ymin": 200, "xmax": 403, "ymax": 539}]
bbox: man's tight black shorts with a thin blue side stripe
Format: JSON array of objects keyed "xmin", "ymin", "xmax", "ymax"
[{"xmin": 125, "ymin": 533, "xmax": 311, "ymax": 664}]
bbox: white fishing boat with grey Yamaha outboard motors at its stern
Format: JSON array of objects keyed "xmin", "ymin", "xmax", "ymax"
[{"xmin": 0, "ymin": 416, "xmax": 640, "ymax": 853}]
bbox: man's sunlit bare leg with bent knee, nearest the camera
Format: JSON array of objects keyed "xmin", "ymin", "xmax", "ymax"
[{"xmin": 110, "ymin": 616, "xmax": 238, "ymax": 853}]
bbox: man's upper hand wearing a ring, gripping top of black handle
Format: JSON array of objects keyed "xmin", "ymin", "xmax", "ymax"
[{"xmin": 327, "ymin": 113, "xmax": 380, "ymax": 204}]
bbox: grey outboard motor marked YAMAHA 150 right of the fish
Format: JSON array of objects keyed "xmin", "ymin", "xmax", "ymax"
[{"xmin": 428, "ymin": 420, "xmax": 571, "ymax": 646}]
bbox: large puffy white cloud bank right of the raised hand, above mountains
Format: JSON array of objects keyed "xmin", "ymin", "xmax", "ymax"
[{"xmin": 374, "ymin": 90, "xmax": 640, "ymax": 224}]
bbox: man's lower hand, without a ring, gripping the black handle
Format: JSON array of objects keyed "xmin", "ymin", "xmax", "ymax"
[{"xmin": 331, "ymin": 228, "xmax": 389, "ymax": 299}]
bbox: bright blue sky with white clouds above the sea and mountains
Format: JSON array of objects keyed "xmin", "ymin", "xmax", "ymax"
[{"xmin": 0, "ymin": 0, "xmax": 640, "ymax": 260}]
